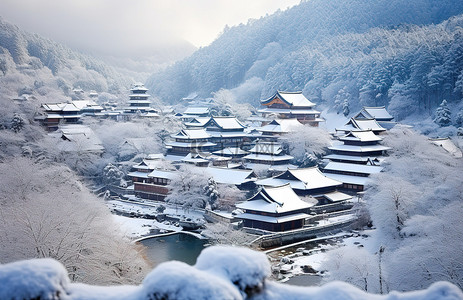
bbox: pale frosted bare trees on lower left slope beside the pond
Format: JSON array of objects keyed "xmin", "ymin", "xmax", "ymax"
[{"xmin": 0, "ymin": 157, "xmax": 147, "ymax": 284}]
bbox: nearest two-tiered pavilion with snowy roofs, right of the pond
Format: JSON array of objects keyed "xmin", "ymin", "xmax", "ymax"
[{"xmin": 236, "ymin": 184, "xmax": 313, "ymax": 232}]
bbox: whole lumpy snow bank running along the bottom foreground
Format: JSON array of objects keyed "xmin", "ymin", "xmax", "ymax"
[{"xmin": 0, "ymin": 246, "xmax": 463, "ymax": 300}]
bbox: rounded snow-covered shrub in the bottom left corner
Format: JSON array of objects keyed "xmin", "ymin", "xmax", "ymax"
[{"xmin": 0, "ymin": 258, "xmax": 70, "ymax": 300}]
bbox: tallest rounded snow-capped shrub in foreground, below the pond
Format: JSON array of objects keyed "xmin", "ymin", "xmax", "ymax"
[{"xmin": 195, "ymin": 246, "xmax": 270, "ymax": 296}]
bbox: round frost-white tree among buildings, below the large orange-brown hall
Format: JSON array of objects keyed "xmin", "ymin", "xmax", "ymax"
[{"xmin": 283, "ymin": 125, "xmax": 331, "ymax": 167}]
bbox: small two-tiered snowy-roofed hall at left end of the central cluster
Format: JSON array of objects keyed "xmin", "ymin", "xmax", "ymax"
[{"xmin": 165, "ymin": 129, "xmax": 216, "ymax": 156}]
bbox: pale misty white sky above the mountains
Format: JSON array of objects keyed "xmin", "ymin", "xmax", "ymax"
[{"xmin": 0, "ymin": 0, "xmax": 300, "ymax": 55}]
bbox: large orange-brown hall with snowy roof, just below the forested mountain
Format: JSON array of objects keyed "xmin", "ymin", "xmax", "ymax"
[{"xmin": 259, "ymin": 91, "xmax": 323, "ymax": 126}]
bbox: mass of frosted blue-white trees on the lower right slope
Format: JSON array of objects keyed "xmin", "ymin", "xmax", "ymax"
[{"xmin": 329, "ymin": 126, "xmax": 463, "ymax": 291}]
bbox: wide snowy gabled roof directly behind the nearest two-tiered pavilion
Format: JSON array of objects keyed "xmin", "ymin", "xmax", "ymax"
[{"xmin": 256, "ymin": 167, "xmax": 342, "ymax": 191}]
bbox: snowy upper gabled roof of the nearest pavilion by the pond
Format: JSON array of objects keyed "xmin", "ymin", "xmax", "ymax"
[{"xmin": 236, "ymin": 184, "xmax": 312, "ymax": 214}]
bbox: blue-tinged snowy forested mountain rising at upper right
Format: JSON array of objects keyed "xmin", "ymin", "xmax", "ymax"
[{"xmin": 148, "ymin": 0, "xmax": 463, "ymax": 118}]
